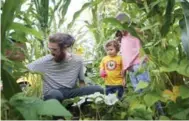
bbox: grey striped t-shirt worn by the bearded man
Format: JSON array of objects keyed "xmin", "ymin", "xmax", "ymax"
[{"xmin": 27, "ymin": 54, "xmax": 84, "ymax": 95}]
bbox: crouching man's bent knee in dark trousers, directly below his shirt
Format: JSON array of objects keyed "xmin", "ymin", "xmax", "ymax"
[{"xmin": 44, "ymin": 90, "xmax": 63, "ymax": 102}]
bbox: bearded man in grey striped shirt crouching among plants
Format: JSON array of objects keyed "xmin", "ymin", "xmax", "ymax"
[{"xmin": 27, "ymin": 33, "xmax": 103, "ymax": 102}]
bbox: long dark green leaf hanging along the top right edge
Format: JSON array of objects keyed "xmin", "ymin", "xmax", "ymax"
[{"xmin": 179, "ymin": 0, "xmax": 189, "ymax": 58}]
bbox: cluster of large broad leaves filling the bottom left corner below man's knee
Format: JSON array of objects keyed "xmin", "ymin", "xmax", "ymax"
[{"xmin": 1, "ymin": 93, "xmax": 72, "ymax": 120}]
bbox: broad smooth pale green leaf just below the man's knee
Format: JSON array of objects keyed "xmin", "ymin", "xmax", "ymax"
[{"xmin": 38, "ymin": 99, "xmax": 72, "ymax": 119}]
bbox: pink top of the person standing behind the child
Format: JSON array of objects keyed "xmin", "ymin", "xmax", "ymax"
[{"xmin": 121, "ymin": 33, "xmax": 141, "ymax": 70}]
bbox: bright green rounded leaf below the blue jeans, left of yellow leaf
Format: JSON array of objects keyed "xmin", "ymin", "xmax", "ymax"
[{"xmin": 144, "ymin": 92, "xmax": 161, "ymax": 107}]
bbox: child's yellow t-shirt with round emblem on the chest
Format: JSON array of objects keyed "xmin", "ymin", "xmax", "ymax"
[{"xmin": 100, "ymin": 55, "xmax": 123, "ymax": 85}]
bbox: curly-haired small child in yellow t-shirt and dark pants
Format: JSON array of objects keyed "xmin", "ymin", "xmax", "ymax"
[{"xmin": 100, "ymin": 40, "xmax": 125, "ymax": 99}]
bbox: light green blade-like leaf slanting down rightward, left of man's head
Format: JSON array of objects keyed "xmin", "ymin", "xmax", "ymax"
[{"xmin": 11, "ymin": 23, "xmax": 43, "ymax": 40}]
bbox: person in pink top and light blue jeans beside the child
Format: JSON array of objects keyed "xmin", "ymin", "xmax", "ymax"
[{"xmin": 116, "ymin": 13, "xmax": 164, "ymax": 115}]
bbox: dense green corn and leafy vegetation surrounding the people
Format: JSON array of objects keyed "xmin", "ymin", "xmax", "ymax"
[{"xmin": 1, "ymin": 0, "xmax": 189, "ymax": 120}]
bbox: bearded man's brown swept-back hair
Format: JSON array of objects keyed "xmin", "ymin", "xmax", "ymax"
[{"xmin": 49, "ymin": 33, "xmax": 75, "ymax": 48}]
